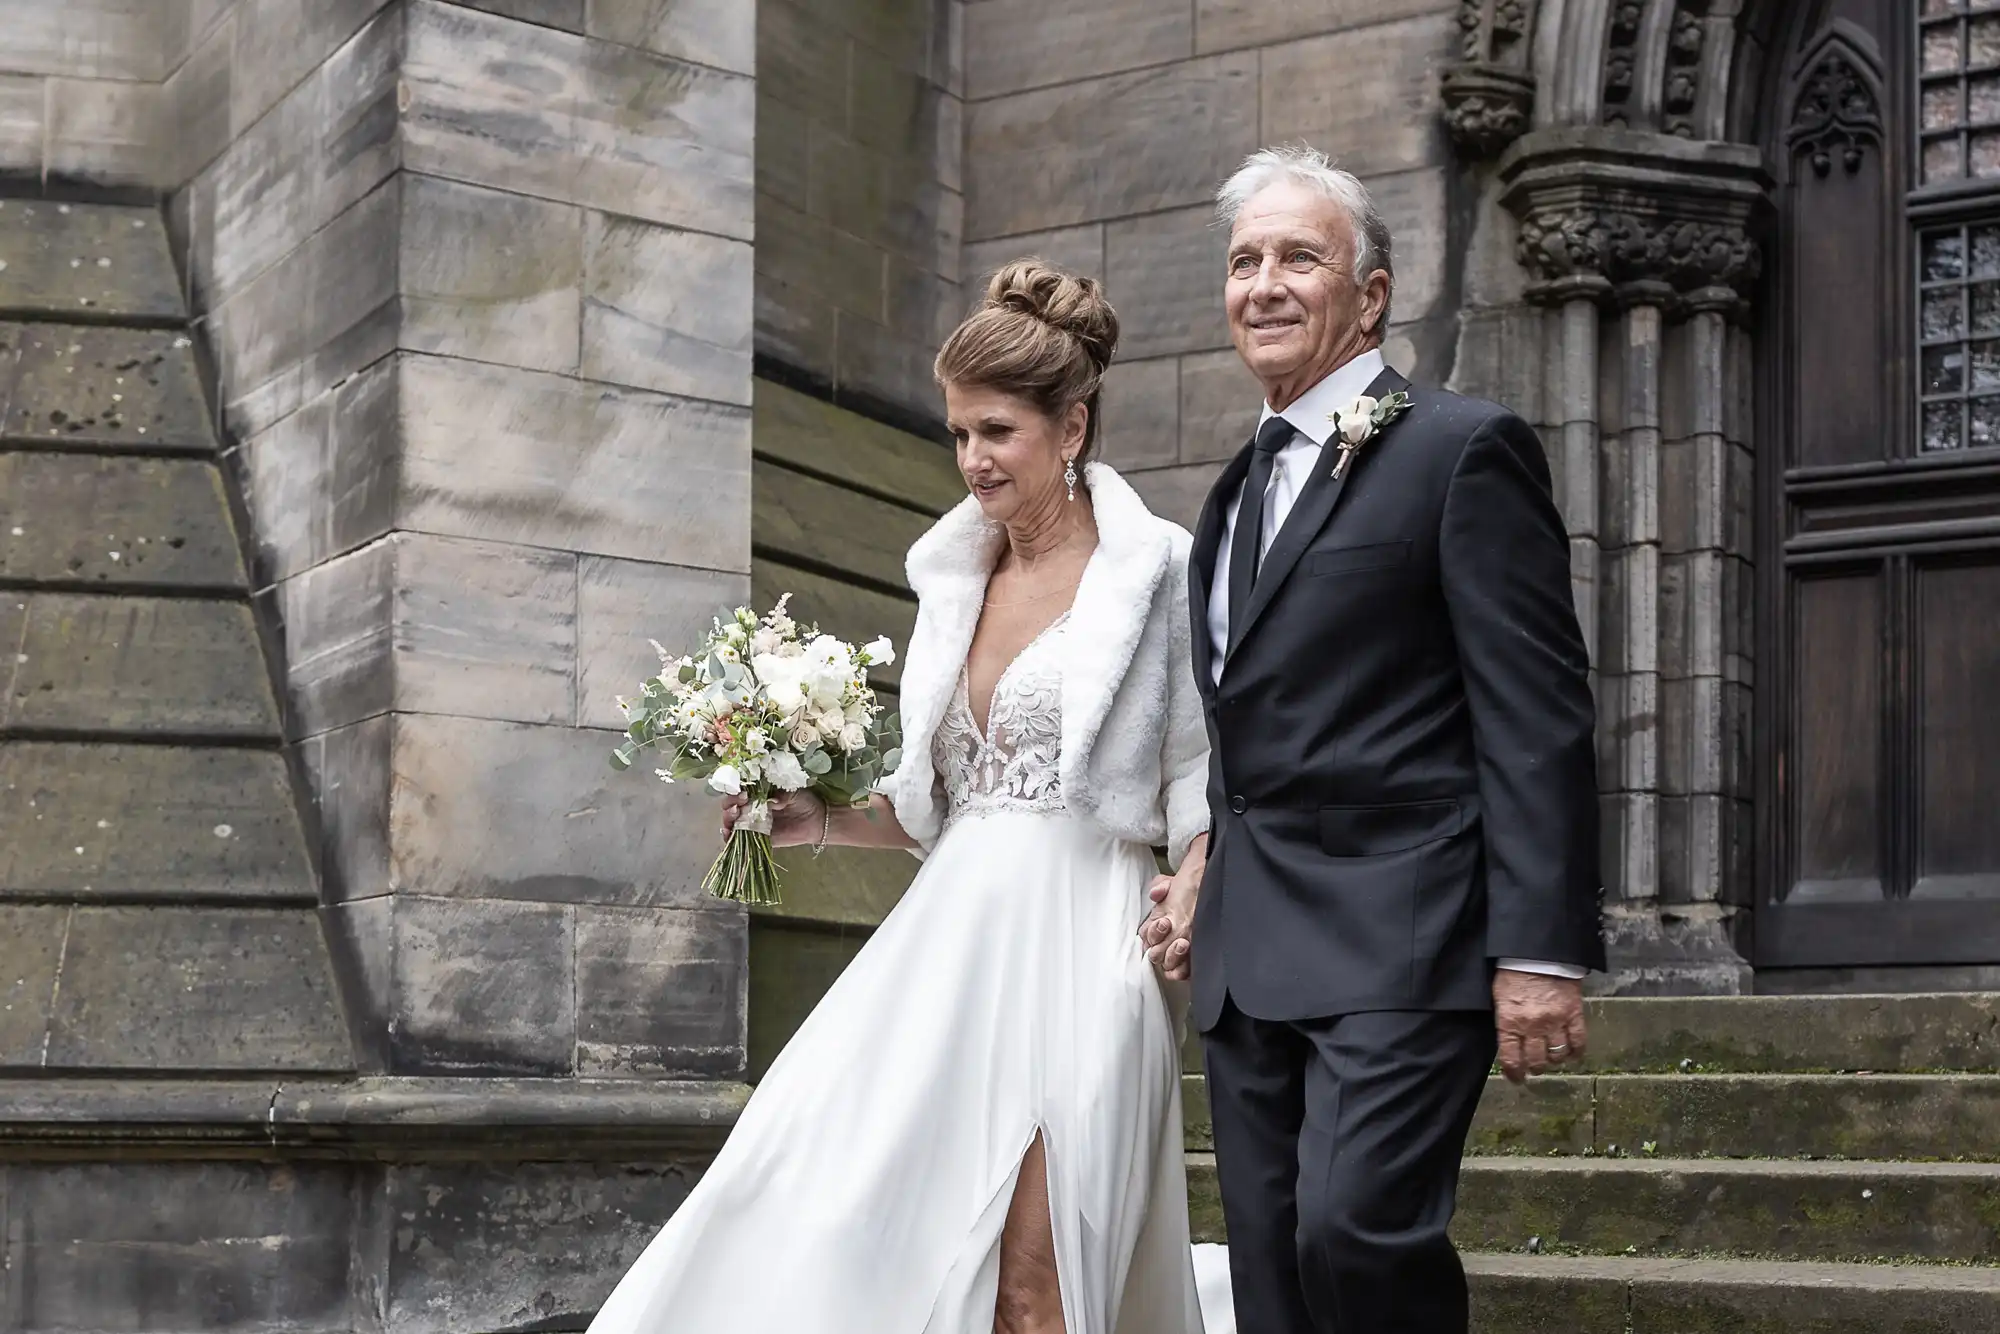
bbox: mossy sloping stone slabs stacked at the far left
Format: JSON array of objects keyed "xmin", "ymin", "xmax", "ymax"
[{"xmin": 0, "ymin": 198, "xmax": 354, "ymax": 1080}]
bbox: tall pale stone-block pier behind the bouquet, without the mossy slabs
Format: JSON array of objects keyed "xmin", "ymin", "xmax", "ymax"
[{"xmin": 154, "ymin": 0, "xmax": 754, "ymax": 1076}]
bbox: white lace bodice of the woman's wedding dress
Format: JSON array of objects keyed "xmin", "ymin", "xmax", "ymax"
[{"xmin": 932, "ymin": 614, "xmax": 1070, "ymax": 824}]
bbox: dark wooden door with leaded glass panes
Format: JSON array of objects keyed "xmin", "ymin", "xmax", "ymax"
[{"xmin": 1756, "ymin": 0, "xmax": 2000, "ymax": 966}]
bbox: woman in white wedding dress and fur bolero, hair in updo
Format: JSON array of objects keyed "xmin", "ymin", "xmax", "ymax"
[{"xmin": 590, "ymin": 260, "xmax": 1226, "ymax": 1334}]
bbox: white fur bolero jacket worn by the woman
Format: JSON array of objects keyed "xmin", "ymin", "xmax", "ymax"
[{"xmin": 882, "ymin": 464, "xmax": 1208, "ymax": 866}]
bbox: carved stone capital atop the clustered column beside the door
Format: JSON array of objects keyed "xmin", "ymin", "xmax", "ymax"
[{"xmin": 1500, "ymin": 128, "xmax": 1770, "ymax": 302}]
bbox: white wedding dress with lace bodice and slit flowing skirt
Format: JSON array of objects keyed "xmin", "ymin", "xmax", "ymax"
[{"xmin": 590, "ymin": 618, "xmax": 1234, "ymax": 1334}]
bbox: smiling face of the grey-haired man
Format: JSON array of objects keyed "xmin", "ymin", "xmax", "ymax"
[{"xmin": 1224, "ymin": 182, "xmax": 1388, "ymax": 406}]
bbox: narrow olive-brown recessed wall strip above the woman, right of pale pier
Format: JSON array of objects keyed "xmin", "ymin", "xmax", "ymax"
[{"xmin": 756, "ymin": 0, "xmax": 966, "ymax": 430}]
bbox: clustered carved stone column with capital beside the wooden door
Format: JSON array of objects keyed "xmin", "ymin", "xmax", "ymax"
[{"xmin": 1500, "ymin": 128, "xmax": 1766, "ymax": 992}]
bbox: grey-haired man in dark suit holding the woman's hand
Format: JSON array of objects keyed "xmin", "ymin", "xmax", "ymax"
[{"xmin": 1150, "ymin": 150, "xmax": 1604, "ymax": 1334}]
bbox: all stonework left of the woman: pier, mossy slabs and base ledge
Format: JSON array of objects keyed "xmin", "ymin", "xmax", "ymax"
[{"xmin": 0, "ymin": 10, "xmax": 764, "ymax": 1334}]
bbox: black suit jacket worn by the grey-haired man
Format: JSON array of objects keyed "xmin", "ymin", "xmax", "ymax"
[{"xmin": 1190, "ymin": 372, "xmax": 1604, "ymax": 1030}]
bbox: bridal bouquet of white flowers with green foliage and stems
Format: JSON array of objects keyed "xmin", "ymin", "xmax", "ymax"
[{"xmin": 612, "ymin": 594, "xmax": 900, "ymax": 904}]
